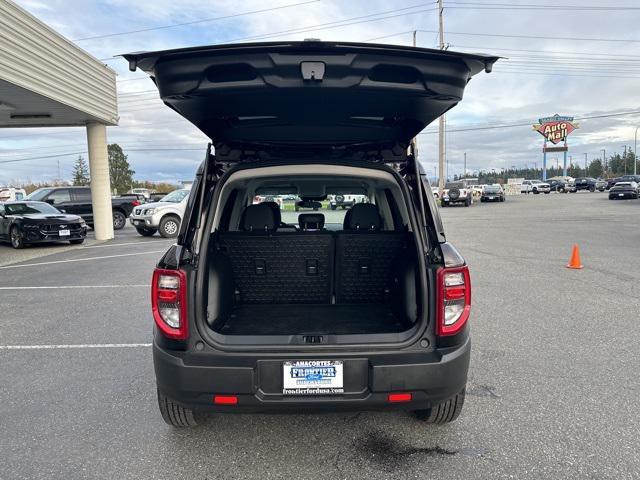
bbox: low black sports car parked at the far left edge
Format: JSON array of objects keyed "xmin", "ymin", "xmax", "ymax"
[{"xmin": 0, "ymin": 201, "xmax": 87, "ymax": 248}]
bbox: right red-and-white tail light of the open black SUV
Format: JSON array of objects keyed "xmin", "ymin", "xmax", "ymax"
[{"xmin": 436, "ymin": 266, "xmax": 471, "ymax": 335}]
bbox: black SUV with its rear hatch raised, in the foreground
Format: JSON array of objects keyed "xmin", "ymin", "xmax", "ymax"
[{"xmin": 125, "ymin": 41, "xmax": 497, "ymax": 426}]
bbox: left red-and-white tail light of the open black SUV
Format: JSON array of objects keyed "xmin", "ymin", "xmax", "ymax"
[{"xmin": 151, "ymin": 268, "xmax": 189, "ymax": 340}]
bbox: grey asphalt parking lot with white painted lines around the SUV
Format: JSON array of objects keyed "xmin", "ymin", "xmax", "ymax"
[{"xmin": 0, "ymin": 193, "xmax": 640, "ymax": 479}]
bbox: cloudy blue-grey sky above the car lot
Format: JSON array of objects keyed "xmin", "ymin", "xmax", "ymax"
[{"xmin": 0, "ymin": 0, "xmax": 640, "ymax": 185}]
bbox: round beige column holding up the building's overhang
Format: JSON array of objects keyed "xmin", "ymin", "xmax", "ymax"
[{"xmin": 87, "ymin": 122, "xmax": 113, "ymax": 240}]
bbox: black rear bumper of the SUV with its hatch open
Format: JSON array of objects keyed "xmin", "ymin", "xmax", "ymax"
[{"xmin": 153, "ymin": 338, "xmax": 471, "ymax": 413}]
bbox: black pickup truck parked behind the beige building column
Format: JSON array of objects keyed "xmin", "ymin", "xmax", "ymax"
[{"xmin": 27, "ymin": 187, "xmax": 136, "ymax": 230}]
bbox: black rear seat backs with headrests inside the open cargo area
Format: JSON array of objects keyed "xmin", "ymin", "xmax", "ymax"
[{"xmin": 216, "ymin": 204, "xmax": 407, "ymax": 304}]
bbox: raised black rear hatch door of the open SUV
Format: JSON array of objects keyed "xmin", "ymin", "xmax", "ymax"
[{"xmin": 124, "ymin": 41, "xmax": 497, "ymax": 160}]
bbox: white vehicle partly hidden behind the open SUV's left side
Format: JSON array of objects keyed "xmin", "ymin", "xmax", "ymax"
[{"xmin": 129, "ymin": 189, "xmax": 190, "ymax": 238}]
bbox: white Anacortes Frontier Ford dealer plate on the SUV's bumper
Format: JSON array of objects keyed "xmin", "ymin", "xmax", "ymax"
[{"xmin": 282, "ymin": 360, "xmax": 344, "ymax": 395}]
